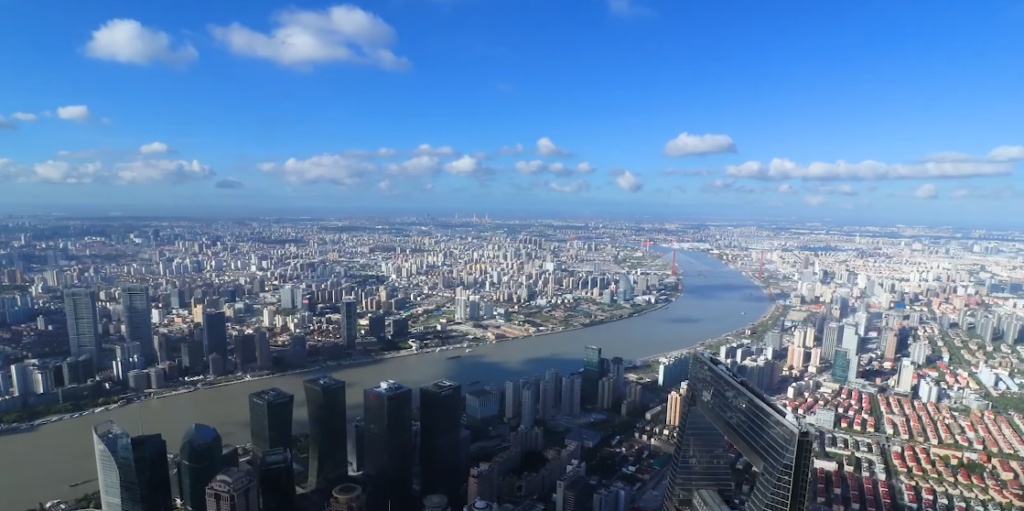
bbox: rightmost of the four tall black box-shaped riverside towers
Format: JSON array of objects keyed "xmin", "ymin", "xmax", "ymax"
[{"xmin": 420, "ymin": 380, "xmax": 469, "ymax": 509}]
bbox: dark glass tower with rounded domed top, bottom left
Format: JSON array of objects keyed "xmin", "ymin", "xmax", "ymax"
[{"xmin": 180, "ymin": 424, "xmax": 223, "ymax": 511}]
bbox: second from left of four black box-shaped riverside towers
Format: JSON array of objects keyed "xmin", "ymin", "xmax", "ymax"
[{"xmin": 303, "ymin": 376, "xmax": 348, "ymax": 489}]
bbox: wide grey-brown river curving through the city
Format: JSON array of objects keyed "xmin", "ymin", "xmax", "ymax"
[{"xmin": 0, "ymin": 252, "xmax": 768, "ymax": 511}]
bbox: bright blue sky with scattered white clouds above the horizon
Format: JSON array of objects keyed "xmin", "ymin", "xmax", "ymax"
[{"xmin": 0, "ymin": 0, "xmax": 1024, "ymax": 223}]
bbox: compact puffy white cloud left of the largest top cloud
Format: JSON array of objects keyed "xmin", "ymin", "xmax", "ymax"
[{"xmin": 85, "ymin": 19, "xmax": 199, "ymax": 66}]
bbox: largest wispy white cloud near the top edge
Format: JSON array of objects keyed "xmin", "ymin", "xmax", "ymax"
[{"xmin": 210, "ymin": 4, "xmax": 410, "ymax": 70}]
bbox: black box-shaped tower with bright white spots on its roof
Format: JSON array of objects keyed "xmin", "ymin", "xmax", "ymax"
[{"xmin": 362, "ymin": 380, "xmax": 417, "ymax": 511}]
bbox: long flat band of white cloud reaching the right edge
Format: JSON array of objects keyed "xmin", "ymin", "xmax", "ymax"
[{"xmin": 725, "ymin": 145, "xmax": 1024, "ymax": 180}]
